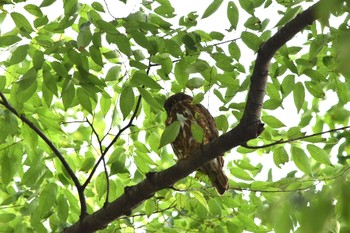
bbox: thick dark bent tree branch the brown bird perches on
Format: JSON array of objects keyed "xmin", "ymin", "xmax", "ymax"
[{"xmin": 65, "ymin": 0, "xmax": 342, "ymax": 232}]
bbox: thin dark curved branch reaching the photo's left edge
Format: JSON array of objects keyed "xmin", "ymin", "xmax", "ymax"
[{"xmin": 0, "ymin": 92, "xmax": 86, "ymax": 216}]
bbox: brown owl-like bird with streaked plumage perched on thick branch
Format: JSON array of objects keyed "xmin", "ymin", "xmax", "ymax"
[{"xmin": 164, "ymin": 93, "xmax": 229, "ymax": 195}]
